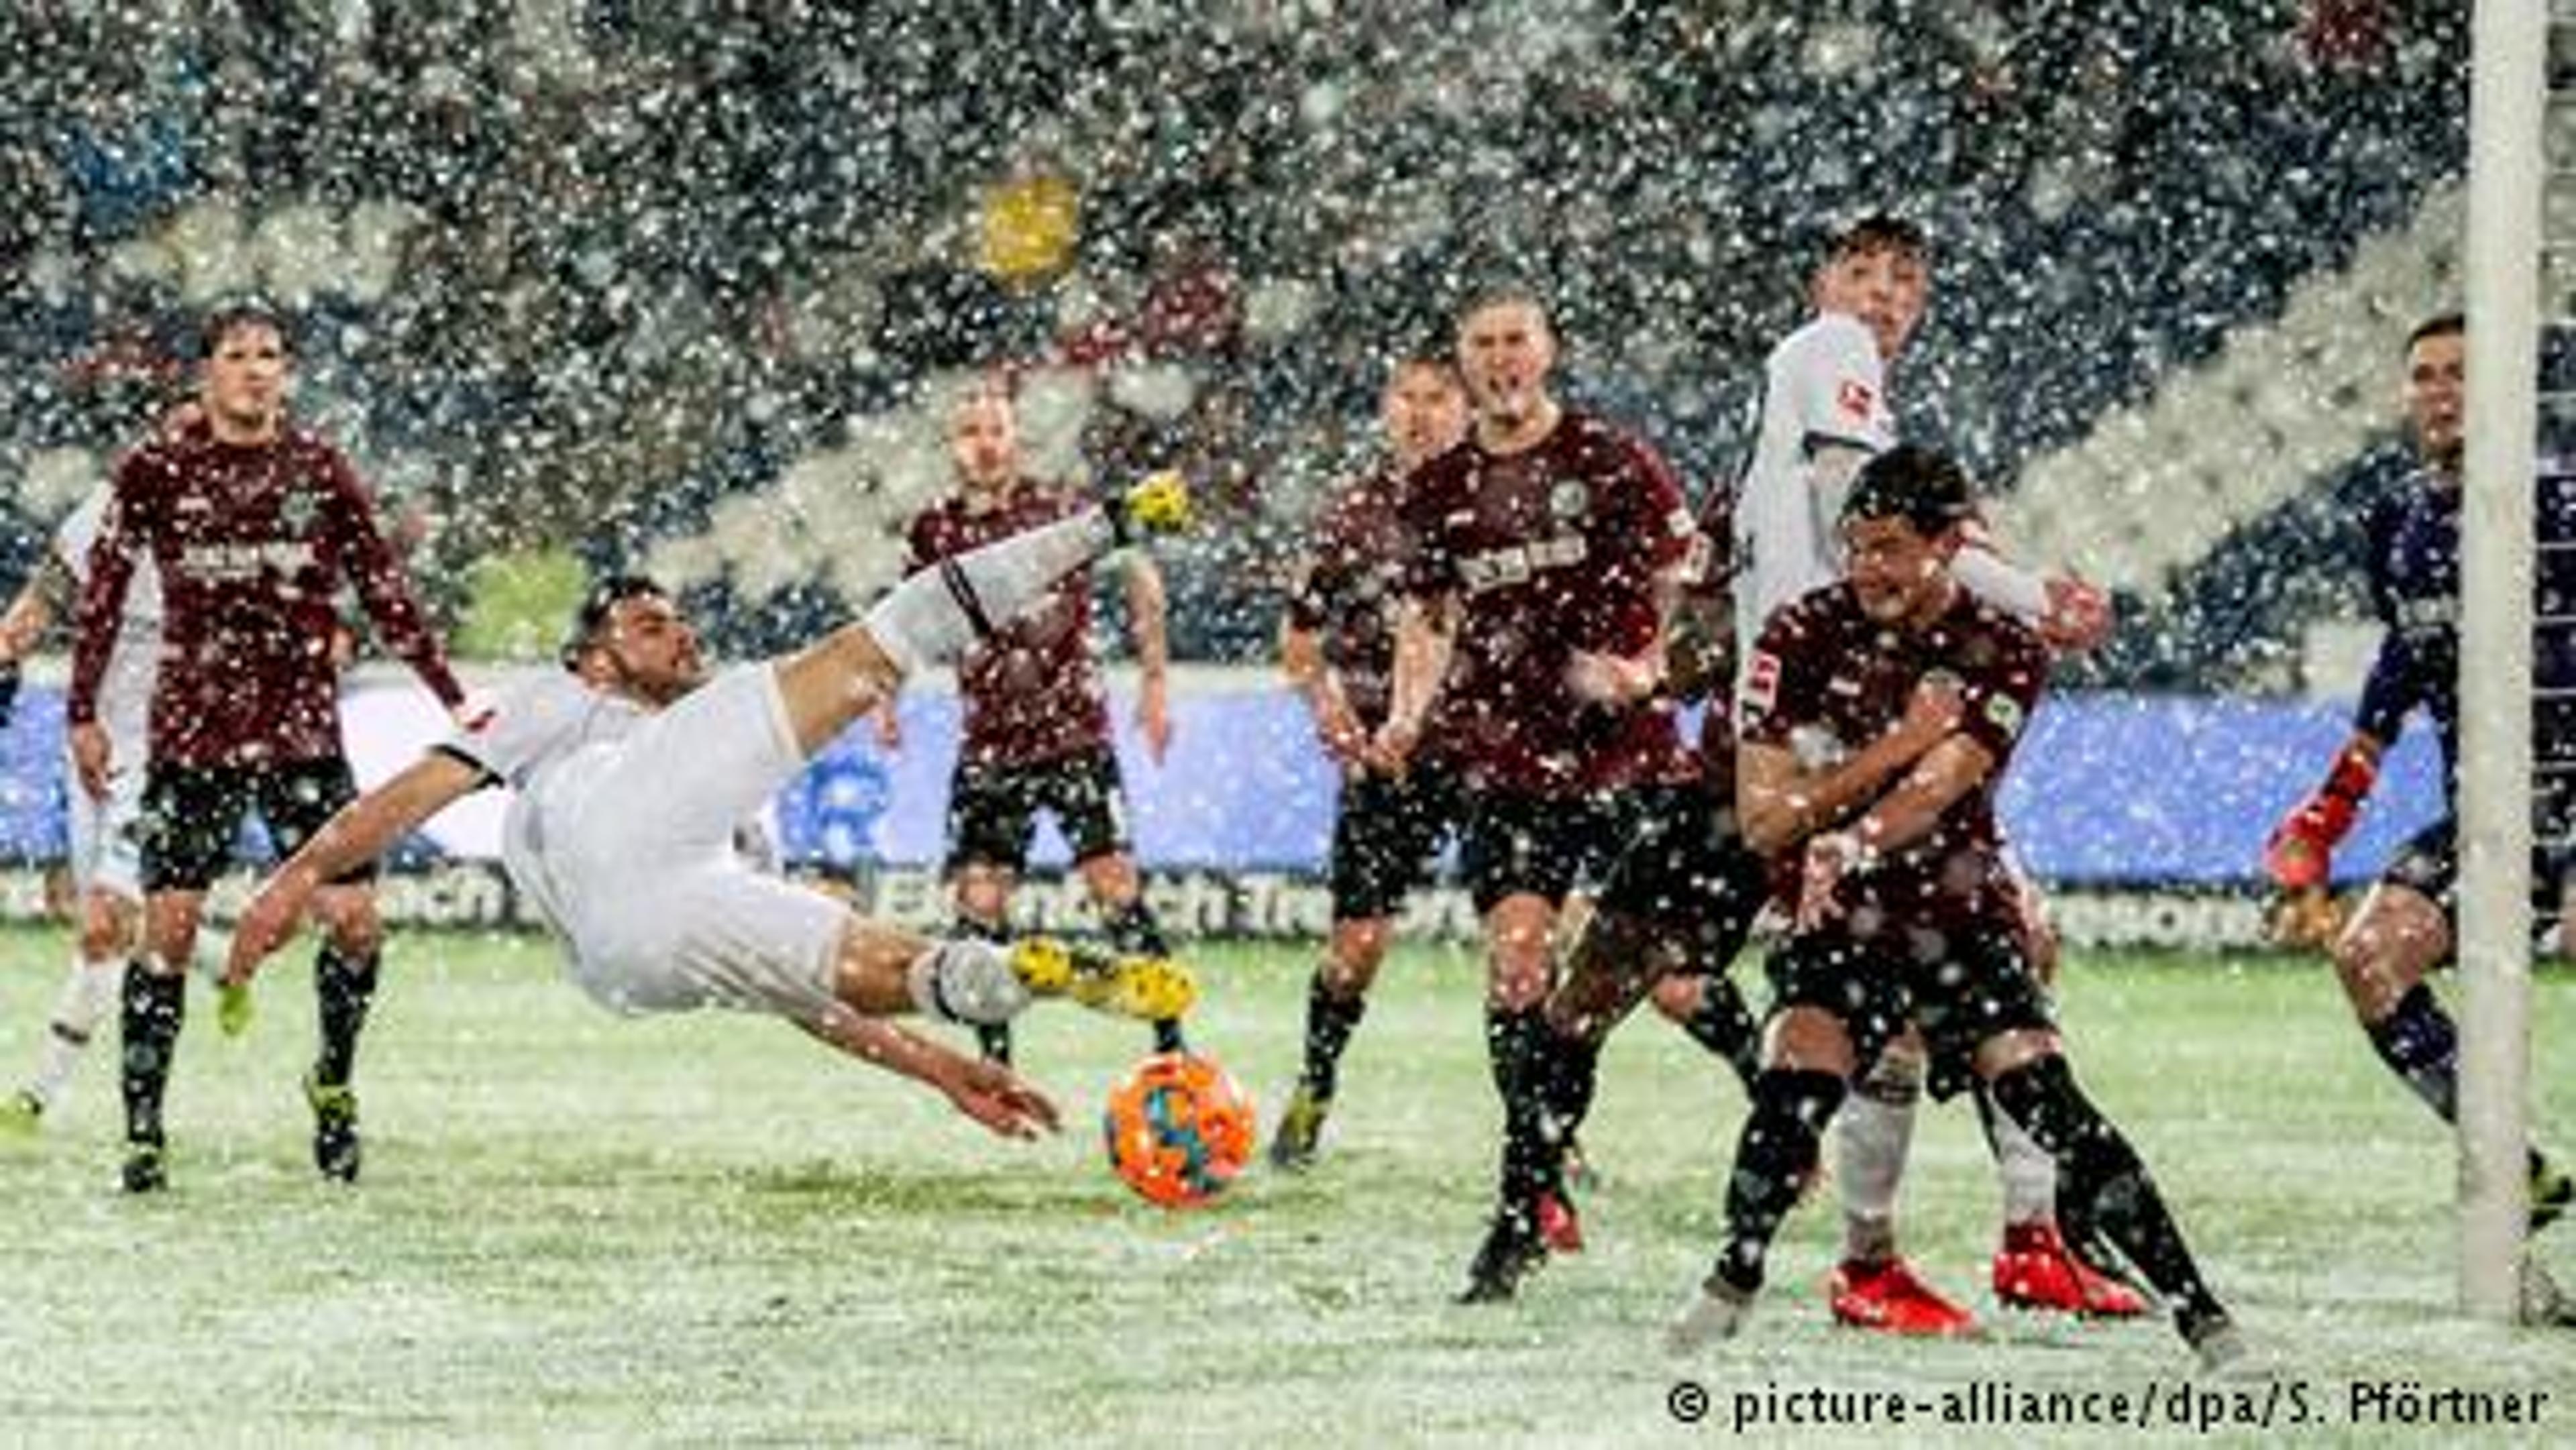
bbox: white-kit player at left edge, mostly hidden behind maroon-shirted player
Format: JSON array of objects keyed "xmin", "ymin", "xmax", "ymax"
[{"xmin": 0, "ymin": 484, "xmax": 160, "ymax": 1133}]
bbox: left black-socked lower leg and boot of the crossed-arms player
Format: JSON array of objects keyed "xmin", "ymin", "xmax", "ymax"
[{"xmin": 1664, "ymin": 1069, "xmax": 1847, "ymax": 1355}]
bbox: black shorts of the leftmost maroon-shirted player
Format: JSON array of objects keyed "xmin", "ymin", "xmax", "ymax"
[{"xmin": 137, "ymin": 755, "xmax": 376, "ymax": 894}]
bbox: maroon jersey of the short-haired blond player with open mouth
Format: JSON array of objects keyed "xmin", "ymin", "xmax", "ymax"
[{"xmin": 1404, "ymin": 412, "xmax": 1693, "ymax": 796}]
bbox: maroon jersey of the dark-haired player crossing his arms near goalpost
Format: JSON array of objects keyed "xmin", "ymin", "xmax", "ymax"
[{"xmin": 1739, "ymin": 585, "xmax": 2048, "ymax": 930}]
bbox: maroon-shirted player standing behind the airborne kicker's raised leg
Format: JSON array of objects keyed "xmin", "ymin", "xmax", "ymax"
[{"xmin": 878, "ymin": 386, "xmax": 1183, "ymax": 1064}]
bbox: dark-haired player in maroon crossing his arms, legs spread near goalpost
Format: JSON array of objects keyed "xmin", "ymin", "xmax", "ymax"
[{"xmin": 1669, "ymin": 445, "xmax": 2244, "ymax": 1368}]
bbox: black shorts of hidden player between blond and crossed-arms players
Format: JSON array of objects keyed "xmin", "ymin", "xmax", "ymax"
[{"xmin": 1600, "ymin": 788, "xmax": 1770, "ymax": 971}]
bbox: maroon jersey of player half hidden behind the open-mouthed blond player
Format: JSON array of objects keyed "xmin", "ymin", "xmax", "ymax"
[{"xmin": 1288, "ymin": 471, "xmax": 1430, "ymax": 744}]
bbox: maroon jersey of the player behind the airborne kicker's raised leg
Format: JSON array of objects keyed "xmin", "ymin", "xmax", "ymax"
[{"xmin": 904, "ymin": 479, "xmax": 1110, "ymax": 765}]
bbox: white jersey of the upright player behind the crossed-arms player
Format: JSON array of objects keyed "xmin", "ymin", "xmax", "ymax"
[{"xmin": 1733, "ymin": 312, "xmax": 1896, "ymax": 667}]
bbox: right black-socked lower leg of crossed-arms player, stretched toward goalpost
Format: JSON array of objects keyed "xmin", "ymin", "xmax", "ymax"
[{"xmin": 1986, "ymin": 1054, "xmax": 2244, "ymax": 1368}]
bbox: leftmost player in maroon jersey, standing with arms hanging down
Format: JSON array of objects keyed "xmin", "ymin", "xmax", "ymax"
[{"xmin": 67, "ymin": 304, "xmax": 464, "ymax": 1192}]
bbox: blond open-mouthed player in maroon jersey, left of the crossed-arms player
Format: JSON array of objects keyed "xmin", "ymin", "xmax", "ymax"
[{"xmin": 1378, "ymin": 291, "xmax": 1693, "ymax": 1298}]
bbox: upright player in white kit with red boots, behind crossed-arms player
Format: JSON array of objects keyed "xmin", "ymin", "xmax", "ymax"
[{"xmin": 1733, "ymin": 217, "xmax": 2112, "ymax": 1334}]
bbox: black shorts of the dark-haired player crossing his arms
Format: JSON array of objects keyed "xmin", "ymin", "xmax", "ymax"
[{"xmin": 1770, "ymin": 925, "xmax": 2058, "ymax": 1097}]
